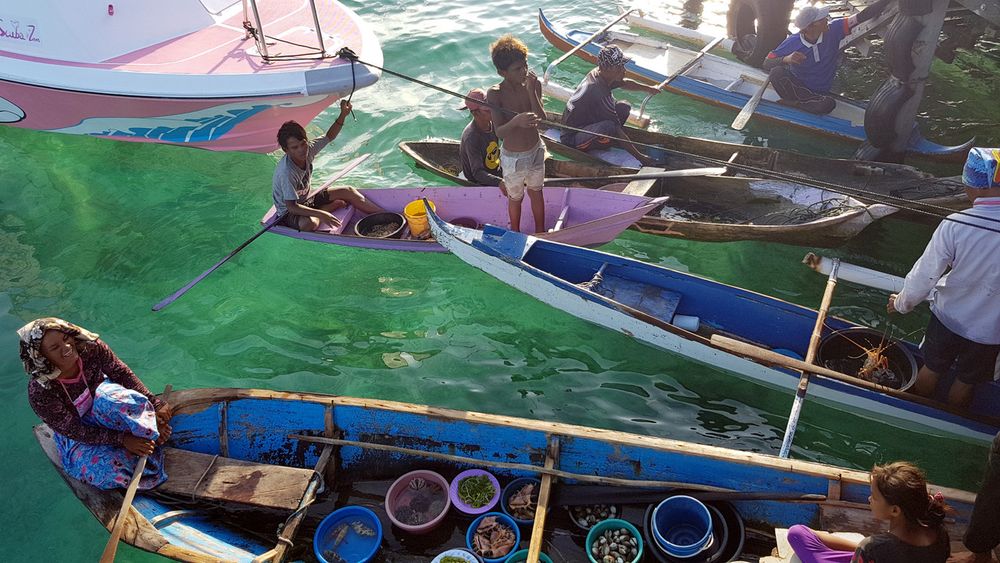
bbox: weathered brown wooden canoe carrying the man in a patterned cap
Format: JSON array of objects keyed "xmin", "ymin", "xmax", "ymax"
[{"xmin": 542, "ymin": 112, "xmax": 969, "ymax": 220}]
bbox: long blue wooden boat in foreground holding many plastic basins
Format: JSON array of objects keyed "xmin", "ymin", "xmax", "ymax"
[{"xmin": 35, "ymin": 389, "xmax": 974, "ymax": 563}]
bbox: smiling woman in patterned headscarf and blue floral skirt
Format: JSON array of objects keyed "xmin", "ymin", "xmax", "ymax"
[{"xmin": 17, "ymin": 317, "xmax": 172, "ymax": 489}]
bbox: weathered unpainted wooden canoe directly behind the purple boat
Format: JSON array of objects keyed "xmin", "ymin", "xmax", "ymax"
[{"xmin": 400, "ymin": 141, "xmax": 896, "ymax": 247}]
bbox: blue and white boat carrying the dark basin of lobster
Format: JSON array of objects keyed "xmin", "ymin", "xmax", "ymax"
[{"xmin": 430, "ymin": 206, "xmax": 1000, "ymax": 442}]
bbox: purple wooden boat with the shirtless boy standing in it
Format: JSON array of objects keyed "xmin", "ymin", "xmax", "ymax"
[{"xmin": 261, "ymin": 186, "xmax": 667, "ymax": 252}]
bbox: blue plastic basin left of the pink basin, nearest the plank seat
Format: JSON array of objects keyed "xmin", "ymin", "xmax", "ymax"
[{"xmin": 313, "ymin": 506, "xmax": 382, "ymax": 563}]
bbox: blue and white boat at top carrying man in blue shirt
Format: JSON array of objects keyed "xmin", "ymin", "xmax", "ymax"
[{"xmin": 538, "ymin": 9, "xmax": 972, "ymax": 159}]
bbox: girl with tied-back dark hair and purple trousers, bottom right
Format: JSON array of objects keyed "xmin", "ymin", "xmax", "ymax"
[{"xmin": 788, "ymin": 461, "xmax": 951, "ymax": 563}]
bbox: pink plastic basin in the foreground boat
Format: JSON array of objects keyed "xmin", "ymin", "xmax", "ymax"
[{"xmin": 385, "ymin": 469, "xmax": 451, "ymax": 534}]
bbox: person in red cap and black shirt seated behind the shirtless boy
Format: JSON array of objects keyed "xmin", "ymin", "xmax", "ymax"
[{"xmin": 458, "ymin": 88, "xmax": 503, "ymax": 186}]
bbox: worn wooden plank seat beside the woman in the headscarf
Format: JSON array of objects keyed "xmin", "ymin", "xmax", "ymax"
[{"xmin": 156, "ymin": 448, "xmax": 313, "ymax": 510}]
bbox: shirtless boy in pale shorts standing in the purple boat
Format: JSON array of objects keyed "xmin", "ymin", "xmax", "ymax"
[{"xmin": 486, "ymin": 34, "xmax": 545, "ymax": 233}]
